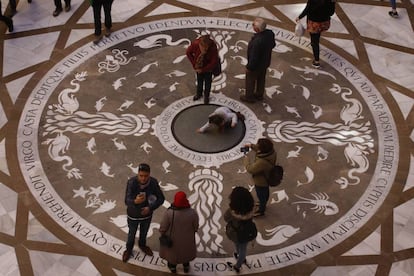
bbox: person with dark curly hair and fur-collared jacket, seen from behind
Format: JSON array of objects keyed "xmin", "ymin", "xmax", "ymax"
[{"xmin": 224, "ymin": 186, "xmax": 257, "ymax": 273}]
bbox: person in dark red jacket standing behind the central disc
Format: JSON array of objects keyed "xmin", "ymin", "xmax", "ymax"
[{"xmin": 186, "ymin": 35, "xmax": 219, "ymax": 104}]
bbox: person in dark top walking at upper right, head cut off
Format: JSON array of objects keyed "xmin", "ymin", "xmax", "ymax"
[{"xmin": 296, "ymin": 0, "xmax": 336, "ymax": 68}]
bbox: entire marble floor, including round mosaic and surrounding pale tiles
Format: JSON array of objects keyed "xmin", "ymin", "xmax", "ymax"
[{"xmin": 0, "ymin": 0, "xmax": 414, "ymax": 276}]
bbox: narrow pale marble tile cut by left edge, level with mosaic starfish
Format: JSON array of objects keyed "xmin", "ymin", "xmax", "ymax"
[{"xmin": 0, "ymin": 182, "xmax": 17, "ymax": 236}]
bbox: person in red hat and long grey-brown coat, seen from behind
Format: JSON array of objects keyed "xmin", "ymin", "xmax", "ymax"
[{"xmin": 159, "ymin": 191, "xmax": 199, "ymax": 273}]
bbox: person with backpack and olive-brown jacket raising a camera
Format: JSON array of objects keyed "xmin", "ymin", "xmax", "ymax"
[{"xmin": 242, "ymin": 138, "xmax": 277, "ymax": 217}]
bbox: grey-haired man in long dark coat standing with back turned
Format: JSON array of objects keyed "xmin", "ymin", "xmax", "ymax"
[{"xmin": 240, "ymin": 18, "xmax": 276, "ymax": 103}]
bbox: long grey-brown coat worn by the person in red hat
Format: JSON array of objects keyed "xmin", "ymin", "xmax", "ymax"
[{"xmin": 159, "ymin": 208, "xmax": 199, "ymax": 264}]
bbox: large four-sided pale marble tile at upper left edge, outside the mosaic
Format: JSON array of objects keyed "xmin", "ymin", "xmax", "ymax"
[{"xmin": 3, "ymin": 32, "xmax": 59, "ymax": 76}]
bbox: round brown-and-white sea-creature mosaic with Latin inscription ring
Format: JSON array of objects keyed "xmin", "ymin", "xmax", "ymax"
[{"xmin": 0, "ymin": 1, "xmax": 410, "ymax": 275}]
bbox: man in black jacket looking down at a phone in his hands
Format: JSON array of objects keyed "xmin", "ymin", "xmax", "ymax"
[{"xmin": 122, "ymin": 163, "xmax": 165, "ymax": 262}]
